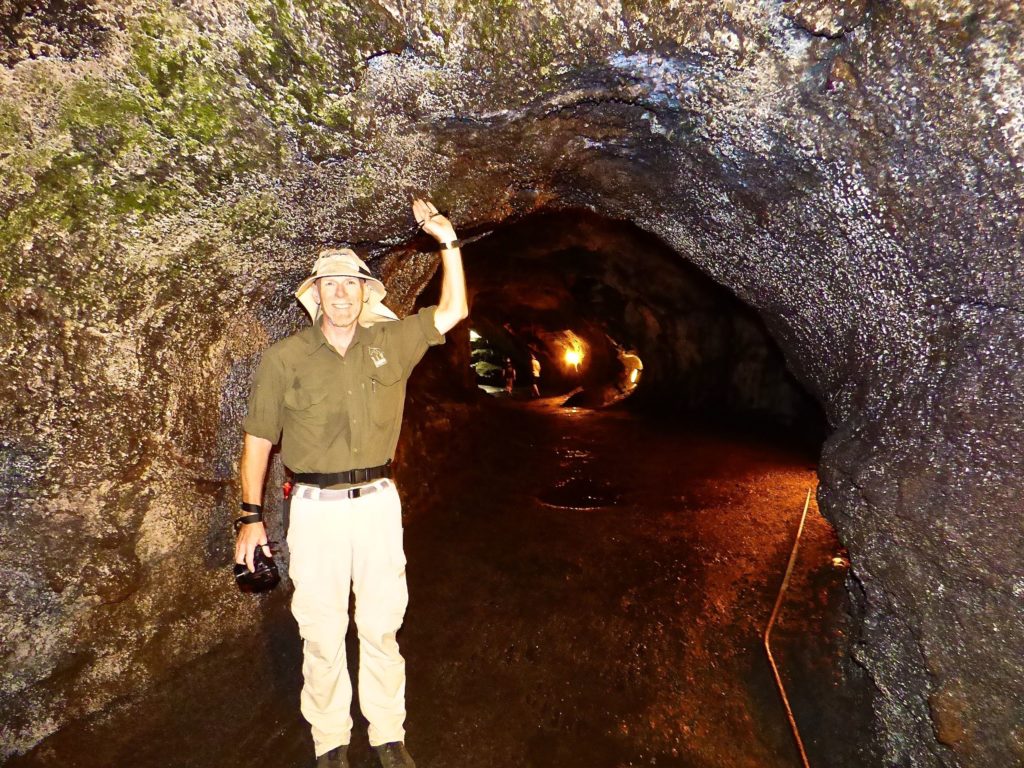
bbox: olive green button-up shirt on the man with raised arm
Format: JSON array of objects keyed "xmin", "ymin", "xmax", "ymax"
[{"xmin": 243, "ymin": 306, "xmax": 444, "ymax": 472}]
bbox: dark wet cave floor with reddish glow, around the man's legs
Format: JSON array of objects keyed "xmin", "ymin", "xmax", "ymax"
[{"xmin": 10, "ymin": 400, "xmax": 876, "ymax": 768}]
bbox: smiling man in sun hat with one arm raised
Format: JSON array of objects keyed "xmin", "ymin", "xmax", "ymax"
[{"xmin": 234, "ymin": 200, "xmax": 467, "ymax": 768}]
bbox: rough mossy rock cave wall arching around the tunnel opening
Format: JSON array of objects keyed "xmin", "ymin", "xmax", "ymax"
[{"xmin": 0, "ymin": 0, "xmax": 1024, "ymax": 766}]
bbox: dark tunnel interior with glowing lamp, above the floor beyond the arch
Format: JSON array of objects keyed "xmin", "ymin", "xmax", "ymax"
[{"xmin": 418, "ymin": 209, "xmax": 825, "ymax": 445}]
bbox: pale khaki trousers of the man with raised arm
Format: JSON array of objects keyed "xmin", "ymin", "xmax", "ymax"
[{"xmin": 288, "ymin": 479, "xmax": 409, "ymax": 756}]
